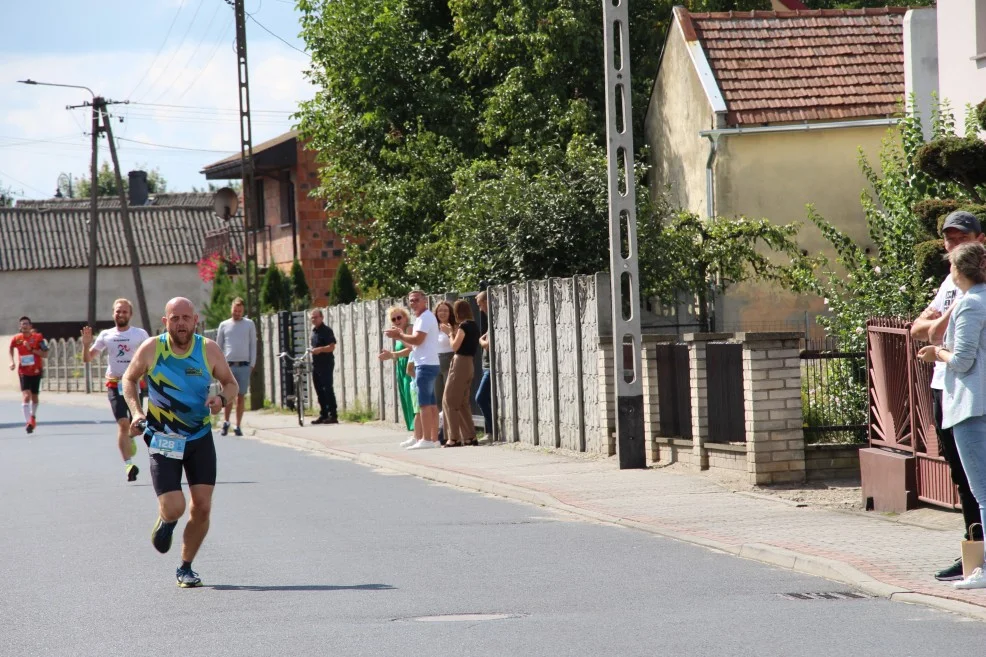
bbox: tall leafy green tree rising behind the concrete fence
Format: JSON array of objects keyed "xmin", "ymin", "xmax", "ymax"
[{"xmin": 299, "ymin": 0, "xmax": 672, "ymax": 294}]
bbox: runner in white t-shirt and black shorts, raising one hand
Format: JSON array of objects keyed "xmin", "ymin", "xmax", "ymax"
[{"xmin": 82, "ymin": 299, "xmax": 149, "ymax": 481}]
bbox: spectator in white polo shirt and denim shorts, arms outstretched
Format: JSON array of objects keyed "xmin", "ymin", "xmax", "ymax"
[{"xmin": 384, "ymin": 290, "xmax": 439, "ymax": 449}]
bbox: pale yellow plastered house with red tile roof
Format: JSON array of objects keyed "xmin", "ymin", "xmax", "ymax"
[{"xmin": 645, "ymin": 0, "xmax": 907, "ymax": 330}]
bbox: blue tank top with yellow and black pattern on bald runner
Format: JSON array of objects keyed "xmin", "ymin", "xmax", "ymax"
[{"xmin": 147, "ymin": 333, "xmax": 212, "ymax": 440}]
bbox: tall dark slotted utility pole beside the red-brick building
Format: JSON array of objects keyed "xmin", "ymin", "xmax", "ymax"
[{"xmin": 226, "ymin": 0, "xmax": 264, "ymax": 409}]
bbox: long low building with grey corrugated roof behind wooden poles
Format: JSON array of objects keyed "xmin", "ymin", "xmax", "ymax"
[{"xmin": 0, "ymin": 187, "xmax": 225, "ymax": 338}]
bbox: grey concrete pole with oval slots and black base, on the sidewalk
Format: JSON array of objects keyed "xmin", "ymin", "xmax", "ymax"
[{"xmin": 602, "ymin": 0, "xmax": 647, "ymax": 470}]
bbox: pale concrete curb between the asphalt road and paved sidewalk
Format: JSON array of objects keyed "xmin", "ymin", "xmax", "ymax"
[{"xmin": 246, "ymin": 429, "xmax": 986, "ymax": 621}]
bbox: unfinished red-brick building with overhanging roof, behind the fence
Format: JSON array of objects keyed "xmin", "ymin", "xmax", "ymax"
[{"xmin": 202, "ymin": 130, "xmax": 342, "ymax": 306}]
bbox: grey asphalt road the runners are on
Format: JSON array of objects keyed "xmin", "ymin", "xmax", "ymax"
[{"xmin": 0, "ymin": 395, "xmax": 986, "ymax": 657}]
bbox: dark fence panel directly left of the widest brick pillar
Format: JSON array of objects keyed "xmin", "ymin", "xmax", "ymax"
[{"xmin": 705, "ymin": 342, "xmax": 746, "ymax": 443}]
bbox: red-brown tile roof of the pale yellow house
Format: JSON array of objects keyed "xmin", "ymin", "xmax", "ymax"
[{"xmin": 689, "ymin": 7, "xmax": 907, "ymax": 125}]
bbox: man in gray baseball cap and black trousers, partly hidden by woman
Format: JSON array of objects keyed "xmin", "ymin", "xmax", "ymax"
[{"xmin": 911, "ymin": 210, "xmax": 986, "ymax": 581}]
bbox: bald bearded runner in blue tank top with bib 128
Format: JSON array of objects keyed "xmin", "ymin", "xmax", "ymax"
[{"xmin": 123, "ymin": 297, "xmax": 239, "ymax": 588}]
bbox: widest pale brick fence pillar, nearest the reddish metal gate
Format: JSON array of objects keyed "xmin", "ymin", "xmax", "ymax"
[{"xmin": 736, "ymin": 332, "xmax": 805, "ymax": 484}]
